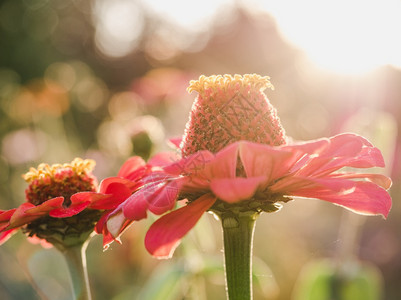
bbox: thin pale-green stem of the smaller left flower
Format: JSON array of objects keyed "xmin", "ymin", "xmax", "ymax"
[{"xmin": 63, "ymin": 242, "xmax": 92, "ymax": 300}]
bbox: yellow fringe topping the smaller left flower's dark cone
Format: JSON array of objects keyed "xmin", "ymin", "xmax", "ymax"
[{"xmin": 22, "ymin": 158, "xmax": 96, "ymax": 183}]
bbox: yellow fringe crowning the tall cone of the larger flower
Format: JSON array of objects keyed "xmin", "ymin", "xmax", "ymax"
[{"xmin": 187, "ymin": 74, "xmax": 274, "ymax": 93}]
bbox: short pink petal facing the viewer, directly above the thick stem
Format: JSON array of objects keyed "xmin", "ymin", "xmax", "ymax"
[{"xmin": 210, "ymin": 176, "xmax": 266, "ymax": 203}]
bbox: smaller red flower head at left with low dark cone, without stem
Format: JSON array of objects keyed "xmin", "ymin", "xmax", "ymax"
[{"xmin": 0, "ymin": 158, "xmax": 136, "ymax": 249}]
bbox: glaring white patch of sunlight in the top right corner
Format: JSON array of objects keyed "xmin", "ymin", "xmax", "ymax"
[{"xmin": 250, "ymin": 0, "xmax": 401, "ymax": 74}]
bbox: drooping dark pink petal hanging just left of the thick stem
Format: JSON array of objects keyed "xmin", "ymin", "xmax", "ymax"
[{"xmin": 145, "ymin": 194, "xmax": 216, "ymax": 258}]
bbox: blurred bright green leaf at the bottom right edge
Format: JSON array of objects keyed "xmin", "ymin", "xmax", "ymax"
[{"xmin": 293, "ymin": 260, "xmax": 383, "ymax": 300}]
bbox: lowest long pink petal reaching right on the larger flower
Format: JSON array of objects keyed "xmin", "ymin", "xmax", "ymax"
[{"xmin": 291, "ymin": 181, "xmax": 391, "ymax": 218}]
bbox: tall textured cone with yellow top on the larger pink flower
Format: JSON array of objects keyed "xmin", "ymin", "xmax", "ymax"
[{"xmin": 181, "ymin": 74, "xmax": 286, "ymax": 157}]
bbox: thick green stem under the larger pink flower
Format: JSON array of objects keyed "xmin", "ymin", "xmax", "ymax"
[{"xmin": 221, "ymin": 214, "xmax": 258, "ymax": 300}]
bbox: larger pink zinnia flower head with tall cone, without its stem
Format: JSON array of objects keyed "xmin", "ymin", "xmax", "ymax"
[{"xmin": 107, "ymin": 74, "xmax": 391, "ymax": 258}]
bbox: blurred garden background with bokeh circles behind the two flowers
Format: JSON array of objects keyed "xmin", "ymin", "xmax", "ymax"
[{"xmin": 0, "ymin": 0, "xmax": 401, "ymax": 300}]
